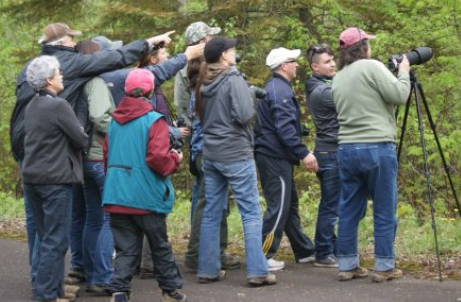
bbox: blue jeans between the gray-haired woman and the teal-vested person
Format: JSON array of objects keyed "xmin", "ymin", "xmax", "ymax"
[{"xmin": 82, "ymin": 161, "xmax": 114, "ymax": 284}]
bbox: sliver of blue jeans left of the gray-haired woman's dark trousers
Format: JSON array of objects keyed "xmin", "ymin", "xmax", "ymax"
[{"xmin": 19, "ymin": 160, "xmax": 40, "ymax": 291}]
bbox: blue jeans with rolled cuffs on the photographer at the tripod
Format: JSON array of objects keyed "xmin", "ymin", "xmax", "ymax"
[{"xmin": 338, "ymin": 143, "xmax": 397, "ymax": 271}]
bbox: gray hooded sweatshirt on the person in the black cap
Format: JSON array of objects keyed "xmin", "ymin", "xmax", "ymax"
[{"xmin": 201, "ymin": 67, "xmax": 255, "ymax": 162}]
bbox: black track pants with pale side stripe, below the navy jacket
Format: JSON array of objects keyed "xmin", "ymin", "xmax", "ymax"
[{"xmin": 256, "ymin": 153, "xmax": 314, "ymax": 259}]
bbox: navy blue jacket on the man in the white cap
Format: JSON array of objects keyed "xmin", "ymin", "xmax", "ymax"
[{"xmin": 255, "ymin": 73, "xmax": 309, "ymax": 164}]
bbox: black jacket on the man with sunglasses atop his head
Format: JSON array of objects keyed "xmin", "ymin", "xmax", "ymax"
[{"xmin": 305, "ymin": 75, "xmax": 339, "ymax": 152}]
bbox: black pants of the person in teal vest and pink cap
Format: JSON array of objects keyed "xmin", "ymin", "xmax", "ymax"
[{"xmin": 108, "ymin": 213, "xmax": 183, "ymax": 293}]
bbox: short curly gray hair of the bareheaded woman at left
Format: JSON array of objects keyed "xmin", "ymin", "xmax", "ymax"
[{"xmin": 26, "ymin": 56, "xmax": 60, "ymax": 91}]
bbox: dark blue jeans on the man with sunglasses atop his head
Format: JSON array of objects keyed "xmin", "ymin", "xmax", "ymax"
[{"xmin": 314, "ymin": 151, "xmax": 341, "ymax": 259}]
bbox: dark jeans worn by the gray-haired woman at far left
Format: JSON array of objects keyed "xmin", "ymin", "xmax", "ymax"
[{"xmin": 24, "ymin": 184, "xmax": 72, "ymax": 301}]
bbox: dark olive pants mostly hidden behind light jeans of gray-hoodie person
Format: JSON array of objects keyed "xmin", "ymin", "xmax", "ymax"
[{"xmin": 185, "ymin": 154, "xmax": 229, "ymax": 267}]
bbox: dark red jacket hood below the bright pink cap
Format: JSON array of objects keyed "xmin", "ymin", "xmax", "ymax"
[{"xmin": 112, "ymin": 97, "xmax": 154, "ymax": 125}]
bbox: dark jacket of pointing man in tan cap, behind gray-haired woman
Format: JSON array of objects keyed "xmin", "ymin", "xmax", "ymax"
[{"xmin": 10, "ymin": 41, "xmax": 148, "ymax": 160}]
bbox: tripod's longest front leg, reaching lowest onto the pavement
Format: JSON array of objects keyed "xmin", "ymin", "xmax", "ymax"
[{"xmin": 412, "ymin": 79, "xmax": 442, "ymax": 282}]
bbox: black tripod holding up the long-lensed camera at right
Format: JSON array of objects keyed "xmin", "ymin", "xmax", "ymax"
[{"xmin": 397, "ymin": 71, "xmax": 461, "ymax": 281}]
